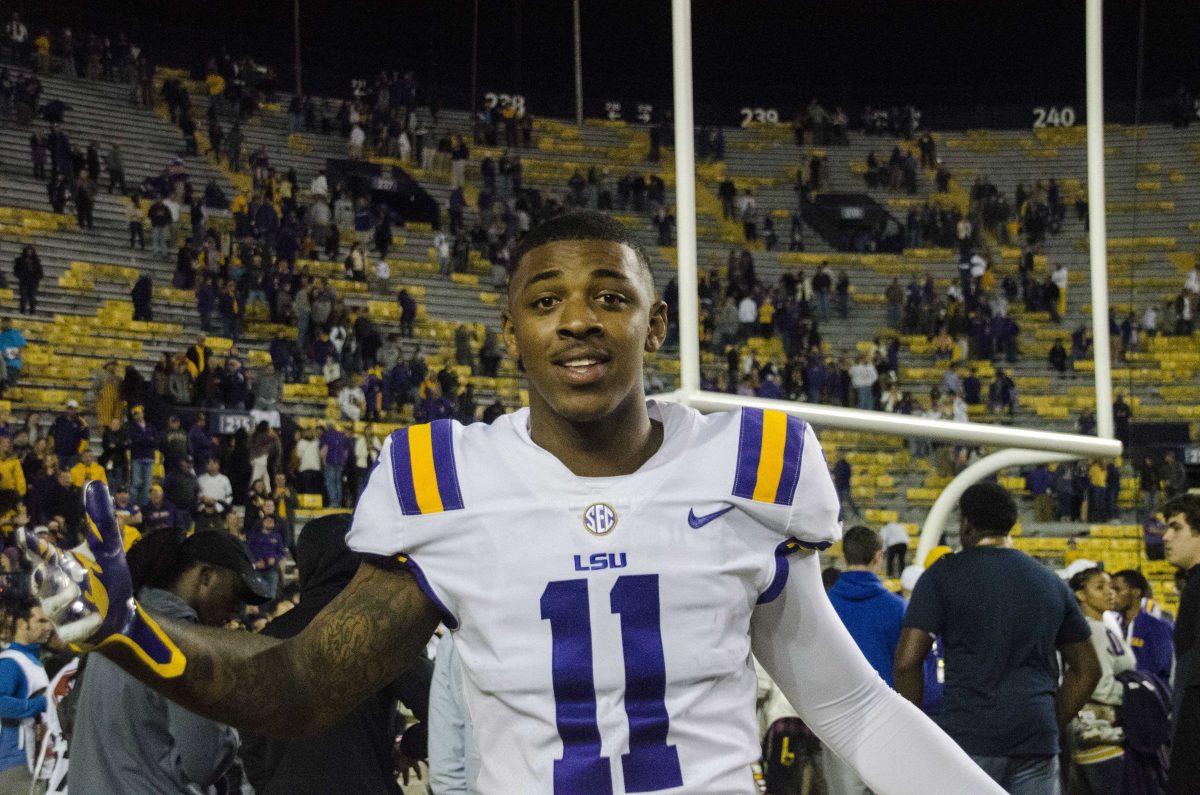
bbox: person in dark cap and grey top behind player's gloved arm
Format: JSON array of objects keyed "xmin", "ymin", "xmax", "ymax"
[{"xmin": 67, "ymin": 530, "xmax": 270, "ymax": 793}]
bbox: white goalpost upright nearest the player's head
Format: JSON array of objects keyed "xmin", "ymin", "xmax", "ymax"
[{"xmin": 672, "ymin": 0, "xmax": 700, "ymax": 404}]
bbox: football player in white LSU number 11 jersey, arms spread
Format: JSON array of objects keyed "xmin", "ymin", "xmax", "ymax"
[{"xmin": 18, "ymin": 213, "xmax": 1001, "ymax": 794}]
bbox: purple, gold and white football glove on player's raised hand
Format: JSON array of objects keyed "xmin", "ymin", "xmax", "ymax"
[{"xmin": 17, "ymin": 480, "xmax": 187, "ymax": 679}]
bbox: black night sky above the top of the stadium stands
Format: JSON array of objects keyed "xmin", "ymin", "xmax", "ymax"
[{"xmin": 6, "ymin": 0, "xmax": 1200, "ymax": 127}]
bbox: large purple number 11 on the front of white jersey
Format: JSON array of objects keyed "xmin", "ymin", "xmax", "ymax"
[{"xmin": 541, "ymin": 574, "xmax": 683, "ymax": 795}]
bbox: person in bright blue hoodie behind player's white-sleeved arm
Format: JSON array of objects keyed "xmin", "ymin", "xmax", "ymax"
[{"xmin": 822, "ymin": 525, "xmax": 904, "ymax": 795}]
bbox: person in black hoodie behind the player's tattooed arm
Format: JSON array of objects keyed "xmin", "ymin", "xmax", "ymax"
[{"xmin": 241, "ymin": 514, "xmax": 433, "ymax": 795}]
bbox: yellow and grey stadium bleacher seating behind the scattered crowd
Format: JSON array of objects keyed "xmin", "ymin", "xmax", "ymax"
[{"xmin": 0, "ymin": 24, "xmax": 1200, "ymax": 614}]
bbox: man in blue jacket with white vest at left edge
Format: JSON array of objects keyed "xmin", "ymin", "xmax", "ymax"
[{"xmin": 0, "ymin": 600, "xmax": 54, "ymax": 795}]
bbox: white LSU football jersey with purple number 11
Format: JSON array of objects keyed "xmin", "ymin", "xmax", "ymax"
[{"xmin": 347, "ymin": 401, "xmax": 841, "ymax": 795}]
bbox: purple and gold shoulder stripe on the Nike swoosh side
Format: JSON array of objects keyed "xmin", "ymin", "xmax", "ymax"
[{"xmin": 733, "ymin": 408, "xmax": 805, "ymax": 506}]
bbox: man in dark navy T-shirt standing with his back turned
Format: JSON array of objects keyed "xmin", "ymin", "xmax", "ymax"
[{"xmin": 895, "ymin": 483, "xmax": 1100, "ymax": 795}]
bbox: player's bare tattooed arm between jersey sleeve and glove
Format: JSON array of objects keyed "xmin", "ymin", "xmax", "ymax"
[{"xmin": 104, "ymin": 561, "xmax": 439, "ymax": 735}]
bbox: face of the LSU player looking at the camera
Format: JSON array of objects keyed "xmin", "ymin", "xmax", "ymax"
[{"xmin": 503, "ymin": 240, "xmax": 667, "ymax": 423}]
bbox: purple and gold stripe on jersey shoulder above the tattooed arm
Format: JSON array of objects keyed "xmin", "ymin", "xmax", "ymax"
[{"xmin": 391, "ymin": 419, "xmax": 463, "ymax": 515}]
